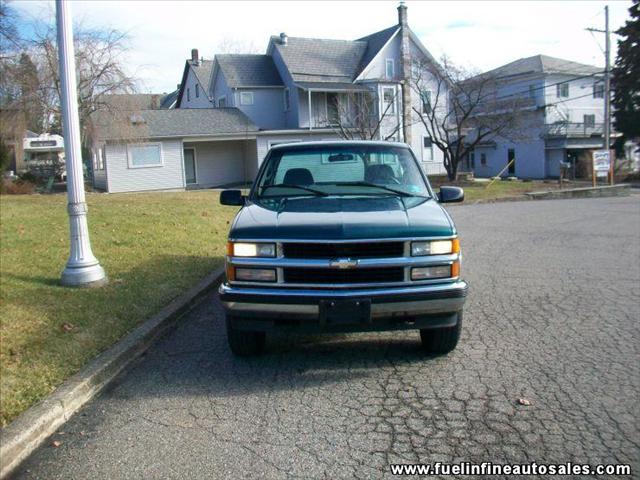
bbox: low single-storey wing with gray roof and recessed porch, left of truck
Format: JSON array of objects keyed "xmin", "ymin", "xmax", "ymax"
[{"xmin": 94, "ymin": 108, "xmax": 258, "ymax": 193}]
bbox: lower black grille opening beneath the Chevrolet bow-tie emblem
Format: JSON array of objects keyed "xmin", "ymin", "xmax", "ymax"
[{"xmin": 283, "ymin": 267, "xmax": 404, "ymax": 284}]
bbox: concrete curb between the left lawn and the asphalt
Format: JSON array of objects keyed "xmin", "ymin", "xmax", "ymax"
[{"xmin": 0, "ymin": 267, "xmax": 224, "ymax": 478}]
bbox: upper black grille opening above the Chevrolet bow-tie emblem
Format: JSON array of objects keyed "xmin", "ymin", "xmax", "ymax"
[{"xmin": 282, "ymin": 242, "xmax": 404, "ymax": 258}]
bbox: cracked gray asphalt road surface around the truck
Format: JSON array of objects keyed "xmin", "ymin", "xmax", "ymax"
[{"xmin": 11, "ymin": 195, "xmax": 640, "ymax": 479}]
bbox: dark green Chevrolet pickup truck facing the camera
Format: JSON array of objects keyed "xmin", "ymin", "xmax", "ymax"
[{"xmin": 219, "ymin": 141, "xmax": 467, "ymax": 355}]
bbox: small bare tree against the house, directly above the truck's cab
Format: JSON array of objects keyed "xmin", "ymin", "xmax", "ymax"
[{"xmin": 327, "ymin": 90, "xmax": 401, "ymax": 140}]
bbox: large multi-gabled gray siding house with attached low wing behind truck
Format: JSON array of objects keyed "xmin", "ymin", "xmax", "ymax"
[{"xmin": 94, "ymin": 5, "xmax": 445, "ymax": 192}]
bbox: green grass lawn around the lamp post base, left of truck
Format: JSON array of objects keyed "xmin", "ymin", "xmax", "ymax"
[{"xmin": 0, "ymin": 190, "xmax": 237, "ymax": 425}]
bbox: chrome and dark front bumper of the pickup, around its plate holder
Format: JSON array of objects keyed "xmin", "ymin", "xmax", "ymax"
[{"xmin": 219, "ymin": 280, "xmax": 468, "ymax": 331}]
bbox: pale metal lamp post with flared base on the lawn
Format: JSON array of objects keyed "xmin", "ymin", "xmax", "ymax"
[{"xmin": 56, "ymin": 0, "xmax": 107, "ymax": 287}]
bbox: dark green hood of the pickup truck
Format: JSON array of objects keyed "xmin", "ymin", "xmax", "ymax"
[{"xmin": 229, "ymin": 197, "xmax": 455, "ymax": 240}]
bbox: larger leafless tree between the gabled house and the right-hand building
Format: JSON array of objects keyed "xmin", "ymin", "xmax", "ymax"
[{"xmin": 410, "ymin": 57, "xmax": 533, "ymax": 180}]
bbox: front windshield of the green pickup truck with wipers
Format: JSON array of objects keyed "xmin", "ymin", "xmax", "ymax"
[{"xmin": 253, "ymin": 144, "xmax": 429, "ymax": 198}]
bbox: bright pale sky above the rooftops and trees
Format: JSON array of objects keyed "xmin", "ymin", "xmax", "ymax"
[{"xmin": 10, "ymin": 0, "xmax": 631, "ymax": 93}]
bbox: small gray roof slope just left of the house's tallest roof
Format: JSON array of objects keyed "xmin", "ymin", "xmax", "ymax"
[{"xmin": 214, "ymin": 54, "xmax": 284, "ymax": 88}]
